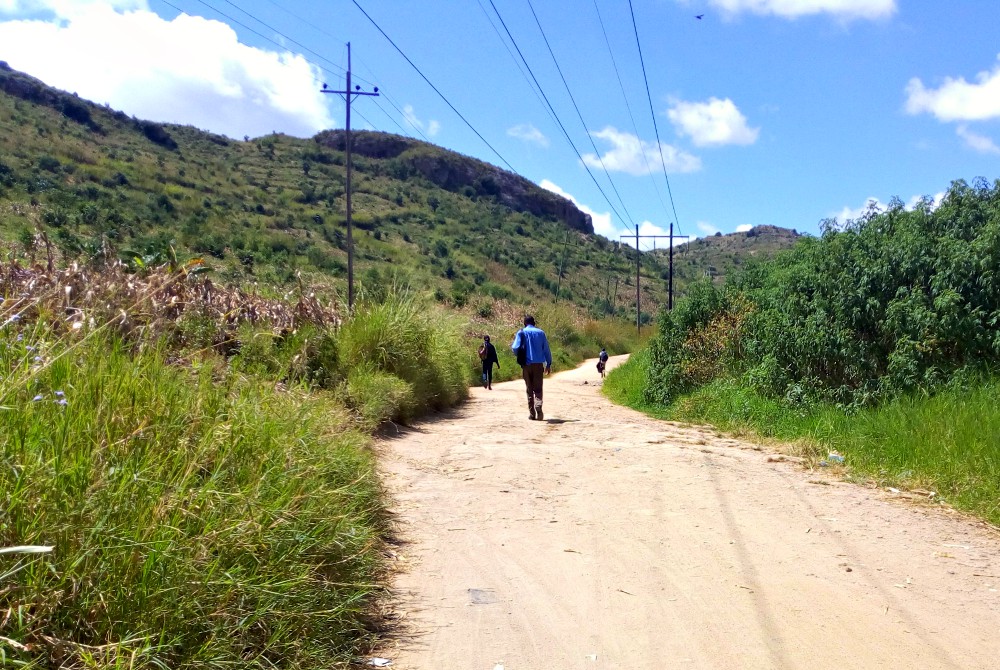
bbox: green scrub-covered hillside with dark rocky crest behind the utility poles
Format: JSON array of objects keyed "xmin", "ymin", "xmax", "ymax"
[{"xmin": 0, "ymin": 63, "xmax": 796, "ymax": 319}]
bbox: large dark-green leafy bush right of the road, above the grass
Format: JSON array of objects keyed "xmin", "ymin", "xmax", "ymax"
[{"xmin": 647, "ymin": 181, "xmax": 1000, "ymax": 405}]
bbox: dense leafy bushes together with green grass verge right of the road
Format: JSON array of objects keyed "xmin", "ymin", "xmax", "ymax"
[{"xmin": 605, "ymin": 181, "xmax": 1000, "ymax": 523}]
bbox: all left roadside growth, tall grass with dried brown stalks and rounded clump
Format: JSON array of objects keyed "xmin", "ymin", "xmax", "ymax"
[{"xmin": 0, "ymin": 267, "xmax": 476, "ymax": 669}]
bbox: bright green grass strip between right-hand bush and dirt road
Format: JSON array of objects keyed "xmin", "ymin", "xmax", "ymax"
[{"xmin": 604, "ymin": 352, "xmax": 1000, "ymax": 524}]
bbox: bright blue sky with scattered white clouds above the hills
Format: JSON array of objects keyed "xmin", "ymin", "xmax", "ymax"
[{"xmin": 0, "ymin": 0, "xmax": 1000, "ymax": 248}]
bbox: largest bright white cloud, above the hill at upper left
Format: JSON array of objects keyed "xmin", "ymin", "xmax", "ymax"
[{"xmin": 0, "ymin": 0, "xmax": 333, "ymax": 137}]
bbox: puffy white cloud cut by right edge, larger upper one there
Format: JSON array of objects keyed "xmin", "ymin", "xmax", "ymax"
[{"xmin": 906, "ymin": 56, "xmax": 1000, "ymax": 121}]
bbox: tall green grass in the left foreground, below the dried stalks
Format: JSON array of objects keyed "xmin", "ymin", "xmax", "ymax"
[{"xmin": 0, "ymin": 329, "xmax": 384, "ymax": 668}]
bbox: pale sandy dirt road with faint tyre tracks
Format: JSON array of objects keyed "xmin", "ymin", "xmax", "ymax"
[{"xmin": 380, "ymin": 362, "xmax": 1000, "ymax": 670}]
